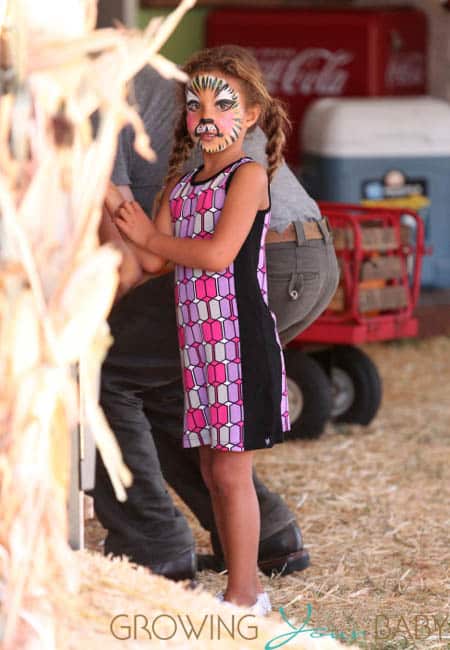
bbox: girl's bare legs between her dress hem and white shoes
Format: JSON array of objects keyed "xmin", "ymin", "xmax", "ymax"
[{"xmin": 200, "ymin": 442, "xmax": 262, "ymax": 606}]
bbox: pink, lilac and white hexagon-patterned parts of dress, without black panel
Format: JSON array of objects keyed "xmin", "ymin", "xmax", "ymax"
[{"xmin": 170, "ymin": 159, "xmax": 289, "ymax": 451}]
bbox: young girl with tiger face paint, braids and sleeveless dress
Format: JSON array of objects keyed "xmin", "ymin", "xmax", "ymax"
[{"xmin": 110, "ymin": 46, "xmax": 289, "ymax": 614}]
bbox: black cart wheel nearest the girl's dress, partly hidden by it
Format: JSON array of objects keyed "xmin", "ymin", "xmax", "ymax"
[{"xmin": 284, "ymin": 348, "xmax": 333, "ymax": 438}]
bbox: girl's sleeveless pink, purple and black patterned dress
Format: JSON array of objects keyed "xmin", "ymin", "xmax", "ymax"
[{"xmin": 169, "ymin": 157, "xmax": 290, "ymax": 451}]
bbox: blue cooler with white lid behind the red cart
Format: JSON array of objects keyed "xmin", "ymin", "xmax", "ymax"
[{"xmin": 301, "ymin": 96, "xmax": 450, "ymax": 288}]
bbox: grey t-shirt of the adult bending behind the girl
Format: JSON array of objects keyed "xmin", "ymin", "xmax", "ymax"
[{"xmin": 112, "ymin": 66, "xmax": 321, "ymax": 232}]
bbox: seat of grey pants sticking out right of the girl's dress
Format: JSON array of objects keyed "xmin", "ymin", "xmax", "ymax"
[{"xmin": 266, "ymin": 222, "xmax": 339, "ymax": 345}]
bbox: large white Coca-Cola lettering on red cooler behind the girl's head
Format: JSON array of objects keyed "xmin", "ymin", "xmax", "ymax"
[{"xmin": 248, "ymin": 47, "xmax": 354, "ymax": 96}]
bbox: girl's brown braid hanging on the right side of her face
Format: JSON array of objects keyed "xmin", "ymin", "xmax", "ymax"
[{"xmin": 261, "ymin": 95, "xmax": 291, "ymax": 183}]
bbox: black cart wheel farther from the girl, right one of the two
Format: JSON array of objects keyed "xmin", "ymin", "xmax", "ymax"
[{"xmin": 331, "ymin": 345, "xmax": 382, "ymax": 424}]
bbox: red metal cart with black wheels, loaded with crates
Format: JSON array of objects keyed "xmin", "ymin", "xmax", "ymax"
[{"xmin": 285, "ymin": 202, "xmax": 427, "ymax": 437}]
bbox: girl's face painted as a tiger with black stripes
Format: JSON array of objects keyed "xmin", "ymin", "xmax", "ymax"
[{"xmin": 186, "ymin": 75, "xmax": 243, "ymax": 153}]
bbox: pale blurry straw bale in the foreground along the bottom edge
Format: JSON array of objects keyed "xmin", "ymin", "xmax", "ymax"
[{"xmin": 57, "ymin": 552, "xmax": 356, "ymax": 650}]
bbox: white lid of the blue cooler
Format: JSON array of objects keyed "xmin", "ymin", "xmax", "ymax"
[{"xmin": 301, "ymin": 96, "xmax": 450, "ymax": 157}]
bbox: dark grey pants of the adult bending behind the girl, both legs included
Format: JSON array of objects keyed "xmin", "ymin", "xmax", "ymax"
[{"xmin": 93, "ymin": 230, "xmax": 337, "ymax": 566}]
